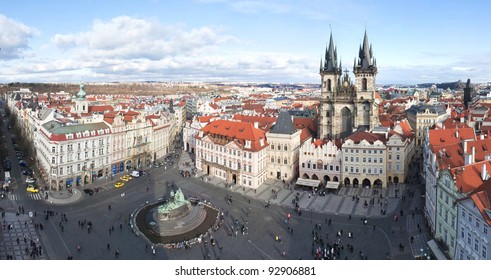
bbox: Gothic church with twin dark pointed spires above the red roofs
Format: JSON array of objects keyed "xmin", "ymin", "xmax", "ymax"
[{"xmin": 318, "ymin": 31, "xmax": 379, "ymax": 139}]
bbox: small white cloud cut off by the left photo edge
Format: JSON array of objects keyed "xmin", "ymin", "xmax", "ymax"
[{"xmin": 0, "ymin": 14, "xmax": 37, "ymax": 60}]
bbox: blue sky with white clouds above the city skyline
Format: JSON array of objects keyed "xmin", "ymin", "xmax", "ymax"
[{"xmin": 0, "ymin": 0, "xmax": 491, "ymax": 85}]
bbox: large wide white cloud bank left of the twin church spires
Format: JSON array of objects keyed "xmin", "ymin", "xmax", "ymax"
[{"xmin": 52, "ymin": 16, "xmax": 236, "ymax": 60}]
